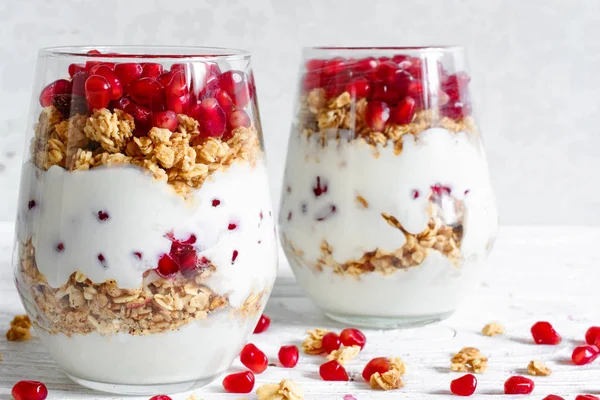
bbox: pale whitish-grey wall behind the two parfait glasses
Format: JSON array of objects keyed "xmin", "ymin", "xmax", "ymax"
[{"xmin": 0, "ymin": 0, "xmax": 600, "ymax": 225}]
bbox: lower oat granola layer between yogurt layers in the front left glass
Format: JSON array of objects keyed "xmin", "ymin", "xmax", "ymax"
[{"xmin": 19, "ymin": 241, "xmax": 266, "ymax": 335}]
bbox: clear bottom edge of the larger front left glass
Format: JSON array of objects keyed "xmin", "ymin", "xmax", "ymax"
[{"xmin": 67, "ymin": 374, "xmax": 220, "ymax": 395}]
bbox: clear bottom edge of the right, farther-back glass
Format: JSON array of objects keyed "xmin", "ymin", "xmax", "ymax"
[{"xmin": 325, "ymin": 311, "xmax": 454, "ymax": 329}]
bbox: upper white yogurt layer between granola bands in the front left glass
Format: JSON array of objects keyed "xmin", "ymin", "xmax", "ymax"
[{"xmin": 17, "ymin": 163, "xmax": 277, "ymax": 307}]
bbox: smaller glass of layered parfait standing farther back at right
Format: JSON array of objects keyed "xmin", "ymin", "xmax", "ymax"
[{"xmin": 279, "ymin": 47, "xmax": 497, "ymax": 328}]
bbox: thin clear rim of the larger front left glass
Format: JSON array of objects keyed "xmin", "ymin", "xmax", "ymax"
[{"xmin": 38, "ymin": 45, "xmax": 250, "ymax": 60}]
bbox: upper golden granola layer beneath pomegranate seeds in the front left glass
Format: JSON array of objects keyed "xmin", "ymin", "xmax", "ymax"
[{"xmin": 31, "ymin": 106, "xmax": 260, "ymax": 195}]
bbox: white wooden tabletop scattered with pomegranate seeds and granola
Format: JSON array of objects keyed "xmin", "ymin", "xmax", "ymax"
[{"xmin": 0, "ymin": 223, "xmax": 600, "ymax": 400}]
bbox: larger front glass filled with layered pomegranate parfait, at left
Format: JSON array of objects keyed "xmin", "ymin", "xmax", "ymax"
[{"xmin": 14, "ymin": 47, "xmax": 277, "ymax": 394}]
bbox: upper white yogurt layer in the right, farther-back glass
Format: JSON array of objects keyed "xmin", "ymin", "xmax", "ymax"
[{"xmin": 280, "ymin": 128, "xmax": 497, "ymax": 263}]
